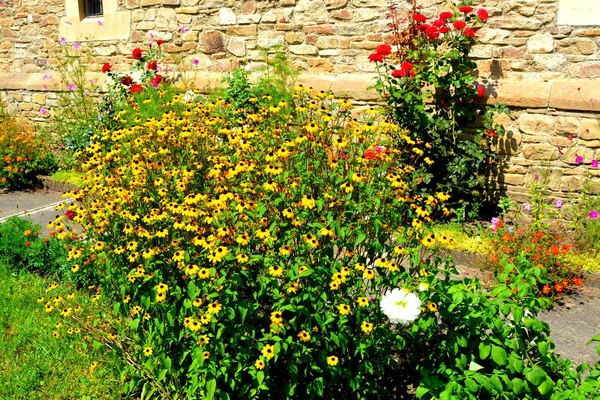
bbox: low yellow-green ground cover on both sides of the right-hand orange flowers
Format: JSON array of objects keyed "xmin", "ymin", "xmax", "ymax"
[{"xmin": 433, "ymin": 223, "xmax": 600, "ymax": 273}]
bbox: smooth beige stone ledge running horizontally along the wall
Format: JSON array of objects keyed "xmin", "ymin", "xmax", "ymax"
[{"xmin": 0, "ymin": 71, "xmax": 600, "ymax": 111}]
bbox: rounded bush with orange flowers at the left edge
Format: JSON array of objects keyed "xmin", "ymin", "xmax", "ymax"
[{"xmin": 0, "ymin": 119, "xmax": 57, "ymax": 189}]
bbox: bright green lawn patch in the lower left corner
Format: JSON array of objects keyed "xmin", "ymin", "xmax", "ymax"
[{"xmin": 0, "ymin": 264, "xmax": 121, "ymax": 400}]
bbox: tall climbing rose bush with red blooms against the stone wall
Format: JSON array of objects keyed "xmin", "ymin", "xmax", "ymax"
[{"xmin": 369, "ymin": 1, "xmax": 508, "ymax": 218}]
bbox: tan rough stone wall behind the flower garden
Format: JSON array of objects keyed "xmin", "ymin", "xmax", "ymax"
[{"xmin": 0, "ymin": 0, "xmax": 600, "ymax": 198}]
